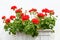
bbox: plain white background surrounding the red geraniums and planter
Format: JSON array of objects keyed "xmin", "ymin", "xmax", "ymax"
[{"xmin": 0, "ymin": 0, "xmax": 60, "ymax": 40}]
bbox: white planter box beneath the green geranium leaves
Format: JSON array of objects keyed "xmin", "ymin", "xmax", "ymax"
[{"xmin": 16, "ymin": 29, "xmax": 54, "ymax": 40}]
